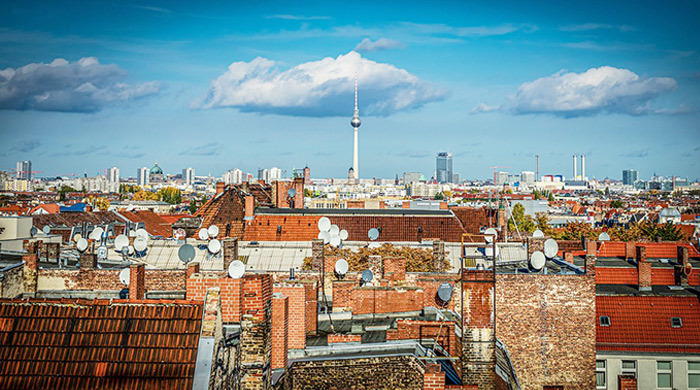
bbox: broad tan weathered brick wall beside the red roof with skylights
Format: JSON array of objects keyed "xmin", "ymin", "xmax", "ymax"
[{"xmin": 496, "ymin": 274, "xmax": 595, "ymax": 390}]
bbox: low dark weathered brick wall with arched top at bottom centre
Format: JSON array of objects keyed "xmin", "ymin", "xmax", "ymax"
[{"xmin": 287, "ymin": 356, "xmax": 424, "ymax": 390}]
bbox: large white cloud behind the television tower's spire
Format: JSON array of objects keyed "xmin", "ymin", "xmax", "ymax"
[{"xmin": 193, "ymin": 51, "xmax": 446, "ymax": 117}]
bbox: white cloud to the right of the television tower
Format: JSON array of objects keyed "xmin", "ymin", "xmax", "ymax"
[{"xmin": 472, "ymin": 66, "xmax": 676, "ymax": 117}]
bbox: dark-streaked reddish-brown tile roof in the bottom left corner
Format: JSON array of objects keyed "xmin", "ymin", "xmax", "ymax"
[{"xmin": 0, "ymin": 299, "xmax": 202, "ymax": 390}]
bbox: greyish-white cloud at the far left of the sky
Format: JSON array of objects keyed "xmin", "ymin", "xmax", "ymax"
[{"xmin": 0, "ymin": 57, "xmax": 160, "ymax": 112}]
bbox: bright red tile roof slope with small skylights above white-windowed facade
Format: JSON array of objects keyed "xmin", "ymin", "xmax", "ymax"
[{"xmin": 596, "ymin": 296, "xmax": 700, "ymax": 353}]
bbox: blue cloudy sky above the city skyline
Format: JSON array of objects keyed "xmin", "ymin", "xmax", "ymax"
[{"xmin": 0, "ymin": 1, "xmax": 700, "ymax": 179}]
